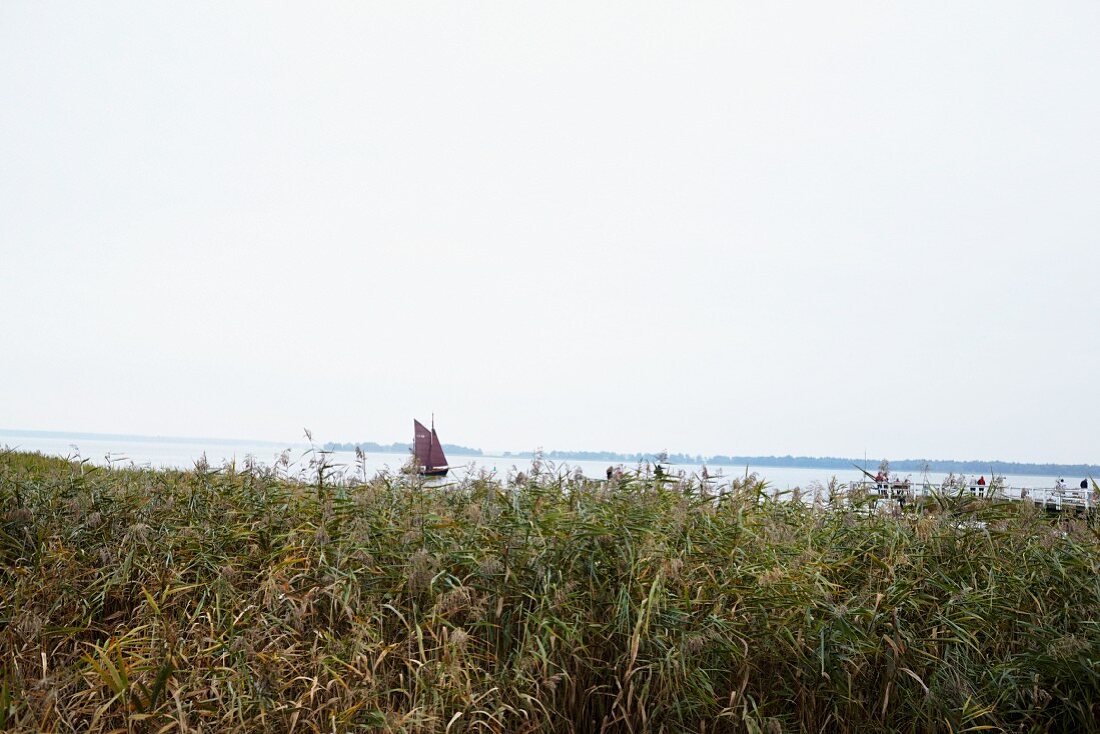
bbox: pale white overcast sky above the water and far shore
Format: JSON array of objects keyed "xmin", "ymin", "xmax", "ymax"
[{"xmin": 0, "ymin": 0, "xmax": 1100, "ymax": 462}]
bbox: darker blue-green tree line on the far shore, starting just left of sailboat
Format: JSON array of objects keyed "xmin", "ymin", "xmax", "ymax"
[{"xmin": 325, "ymin": 441, "xmax": 1100, "ymax": 478}]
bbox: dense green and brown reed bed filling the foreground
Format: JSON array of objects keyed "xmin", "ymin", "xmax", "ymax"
[{"xmin": 0, "ymin": 450, "xmax": 1100, "ymax": 734}]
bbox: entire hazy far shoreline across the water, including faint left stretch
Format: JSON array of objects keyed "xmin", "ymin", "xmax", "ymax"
[{"xmin": 0, "ymin": 428, "xmax": 1100, "ymax": 478}]
